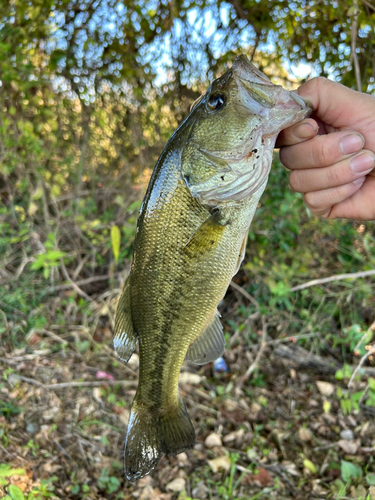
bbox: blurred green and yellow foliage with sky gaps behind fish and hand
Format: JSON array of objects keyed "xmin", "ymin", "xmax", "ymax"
[{"xmin": 0, "ymin": 0, "xmax": 375, "ymax": 498}]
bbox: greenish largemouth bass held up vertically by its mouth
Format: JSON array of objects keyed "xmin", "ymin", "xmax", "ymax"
[{"xmin": 114, "ymin": 55, "xmax": 311, "ymax": 481}]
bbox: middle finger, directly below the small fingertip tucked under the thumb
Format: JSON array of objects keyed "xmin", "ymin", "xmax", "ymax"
[{"xmin": 280, "ymin": 130, "xmax": 365, "ymax": 169}]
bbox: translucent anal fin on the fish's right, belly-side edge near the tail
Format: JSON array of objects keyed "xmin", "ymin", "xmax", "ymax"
[{"xmin": 185, "ymin": 311, "xmax": 225, "ymax": 365}]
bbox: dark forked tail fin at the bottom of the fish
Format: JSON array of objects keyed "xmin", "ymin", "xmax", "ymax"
[{"xmin": 125, "ymin": 399, "xmax": 195, "ymax": 481}]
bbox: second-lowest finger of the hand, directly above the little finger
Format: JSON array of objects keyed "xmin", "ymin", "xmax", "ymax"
[{"xmin": 289, "ymin": 150, "xmax": 375, "ymax": 193}]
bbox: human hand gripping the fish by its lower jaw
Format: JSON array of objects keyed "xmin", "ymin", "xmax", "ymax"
[{"xmin": 276, "ymin": 77, "xmax": 375, "ymax": 220}]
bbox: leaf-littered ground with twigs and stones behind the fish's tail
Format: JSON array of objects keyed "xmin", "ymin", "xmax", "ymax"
[{"xmin": 0, "ymin": 288, "xmax": 375, "ymax": 500}]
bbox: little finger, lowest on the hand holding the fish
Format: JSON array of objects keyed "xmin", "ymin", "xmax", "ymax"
[{"xmin": 303, "ymin": 177, "xmax": 366, "ymax": 218}]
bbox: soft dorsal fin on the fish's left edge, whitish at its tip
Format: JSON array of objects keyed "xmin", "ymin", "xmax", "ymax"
[{"xmin": 113, "ymin": 278, "xmax": 137, "ymax": 362}]
